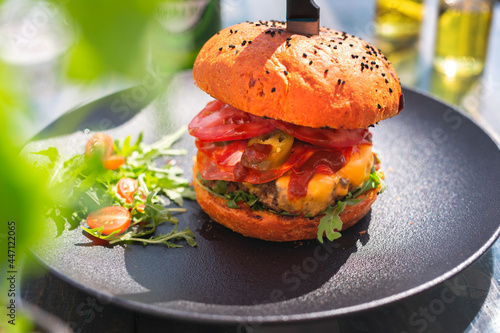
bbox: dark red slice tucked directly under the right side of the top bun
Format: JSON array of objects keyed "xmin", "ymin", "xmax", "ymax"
[{"xmin": 270, "ymin": 120, "xmax": 371, "ymax": 148}]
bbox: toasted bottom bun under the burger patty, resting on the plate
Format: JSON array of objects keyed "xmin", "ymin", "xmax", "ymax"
[{"xmin": 193, "ymin": 163, "xmax": 380, "ymax": 242}]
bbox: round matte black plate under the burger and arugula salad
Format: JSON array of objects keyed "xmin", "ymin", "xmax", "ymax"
[{"xmin": 27, "ymin": 73, "xmax": 500, "ymax": 323}]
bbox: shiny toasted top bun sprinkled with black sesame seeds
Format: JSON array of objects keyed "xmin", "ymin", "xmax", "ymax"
[{"xmin": 193, "ymin": 21, "xmax": 403, "ymax": 129}]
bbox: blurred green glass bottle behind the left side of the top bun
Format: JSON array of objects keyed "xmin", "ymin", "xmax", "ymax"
[{"xmin": 149, "ymin": 0, "xmax": 221, "ymax": 72}]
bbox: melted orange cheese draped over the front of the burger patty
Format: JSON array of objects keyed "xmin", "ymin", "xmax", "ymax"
[{"xmin": 276, "ymin": 145, "xmax": 373, "ymax": 216}]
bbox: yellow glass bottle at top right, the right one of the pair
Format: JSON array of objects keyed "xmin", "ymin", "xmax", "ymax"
[{"xmin": 434, "ymin": 0, "xmax": 493, "ymax": 76}]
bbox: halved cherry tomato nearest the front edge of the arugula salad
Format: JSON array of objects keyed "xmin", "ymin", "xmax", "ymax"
[{"xmin": 87, "ymin": 206, "xmax": 130, "ymax": 235}]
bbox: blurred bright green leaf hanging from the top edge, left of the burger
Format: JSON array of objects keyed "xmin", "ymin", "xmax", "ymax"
[{"xmin": 59, "ymin": 0, "xmax": 160, "ymax": 80}]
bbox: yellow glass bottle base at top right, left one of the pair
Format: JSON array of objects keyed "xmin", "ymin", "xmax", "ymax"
[{"xmin": 375, "ymin": 0, "xmax": 424, "ymax": 40}]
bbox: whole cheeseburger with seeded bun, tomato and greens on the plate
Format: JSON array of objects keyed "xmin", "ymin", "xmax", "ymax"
[{"xmin": 189, "ymin": 21, "xmax": 403, "ymax": 242}]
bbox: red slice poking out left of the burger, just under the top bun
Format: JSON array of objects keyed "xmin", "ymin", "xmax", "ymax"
[{"xmin": 188, "ymin": 100, "xmax": 274, "ymax": 142}]
